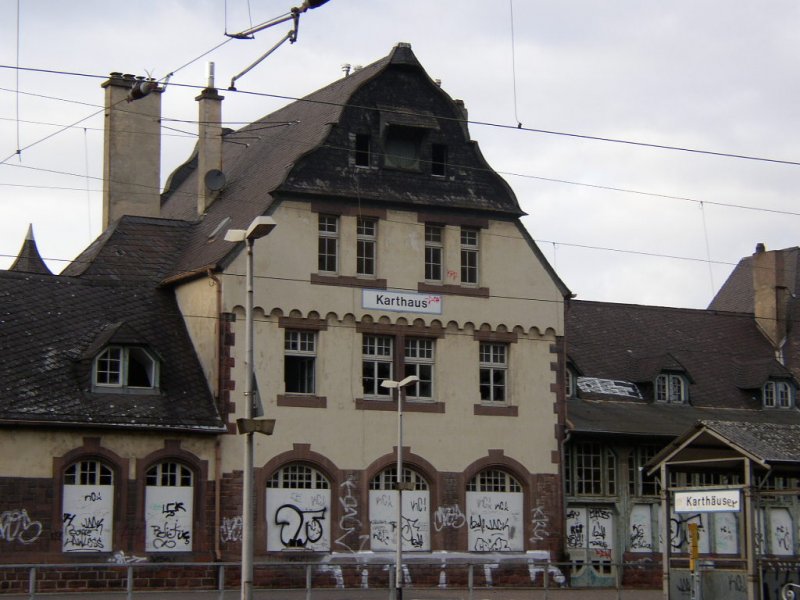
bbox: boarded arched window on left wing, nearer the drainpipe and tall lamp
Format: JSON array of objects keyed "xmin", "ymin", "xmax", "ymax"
[{"xmin": 144, "ymin": 461, "xmax": 194, "ymax": 552}]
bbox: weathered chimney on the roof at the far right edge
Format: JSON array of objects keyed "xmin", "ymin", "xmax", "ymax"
[{"xmin": 753, "ymin": 244, "xmax": 789, "ymax": 356}]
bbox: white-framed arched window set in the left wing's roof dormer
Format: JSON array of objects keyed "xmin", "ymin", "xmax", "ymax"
[{"xmin": 92, "ymin": 344, "xmax": 161, "ymax": 394}]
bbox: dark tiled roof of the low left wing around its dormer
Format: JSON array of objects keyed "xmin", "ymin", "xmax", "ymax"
[{"xmin": 0, "ymin": 217, "xmax": 224, "ymax": 433}]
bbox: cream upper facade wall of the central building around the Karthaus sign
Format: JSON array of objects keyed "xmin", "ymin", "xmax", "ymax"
[{"xmin": 221, "ymin": 202, "xmax": 563, "ymax": 474}]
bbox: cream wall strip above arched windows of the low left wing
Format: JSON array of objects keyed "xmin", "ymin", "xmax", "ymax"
[{"xmin": 0, "ymin": 429, "xmax": 214, "ymax": 479}]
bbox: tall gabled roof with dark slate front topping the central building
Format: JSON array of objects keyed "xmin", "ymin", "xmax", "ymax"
[{"xmin": 161, "ymin": 44, "xmax": 523, "ymax": 280}]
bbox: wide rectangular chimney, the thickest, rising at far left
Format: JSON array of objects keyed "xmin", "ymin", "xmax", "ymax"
[{"xmin": 102, "ymin": 73, "xmax": 164, "ymax": 229}]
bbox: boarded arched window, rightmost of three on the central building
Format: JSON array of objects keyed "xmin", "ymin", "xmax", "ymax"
[{"xmin": 467, "ymin": 468, "xmax": 525, "ymax": 552}]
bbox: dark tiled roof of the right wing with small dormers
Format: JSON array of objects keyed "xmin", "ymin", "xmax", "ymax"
[{"xmin": 566, "ymin": 300, "xmax": 800, "ymax": 436}]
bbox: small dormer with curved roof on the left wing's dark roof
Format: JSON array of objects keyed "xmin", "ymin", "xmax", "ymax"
[{"xmin": 84, "ymin": 322, "xmax": 162, "ymax": 394}]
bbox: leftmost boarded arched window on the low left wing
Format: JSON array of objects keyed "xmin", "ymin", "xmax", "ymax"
[{"xmin": 61, "ymin": 459, "xmax": 114, "ymax": 552}]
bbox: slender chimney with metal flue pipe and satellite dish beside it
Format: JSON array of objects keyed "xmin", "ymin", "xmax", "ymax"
[{"xmin": 195, "ymin": 62, "xmax": 225, "ymax": 216}]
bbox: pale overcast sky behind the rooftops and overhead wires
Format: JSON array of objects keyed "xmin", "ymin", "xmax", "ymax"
[{"xmin": 0, "ymin": 0, "xmax": 800, "ymax": 308}]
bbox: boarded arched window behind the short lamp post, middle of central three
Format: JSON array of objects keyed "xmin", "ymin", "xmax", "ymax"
[{"xmin": 369, "ymin": 466, "xmax": 431, "ymax": 552}]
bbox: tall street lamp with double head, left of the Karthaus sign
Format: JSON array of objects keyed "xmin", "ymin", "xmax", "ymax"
[{"xmin": 225, "ymin": 216, "xmax": 275, "ymax": 600}]
